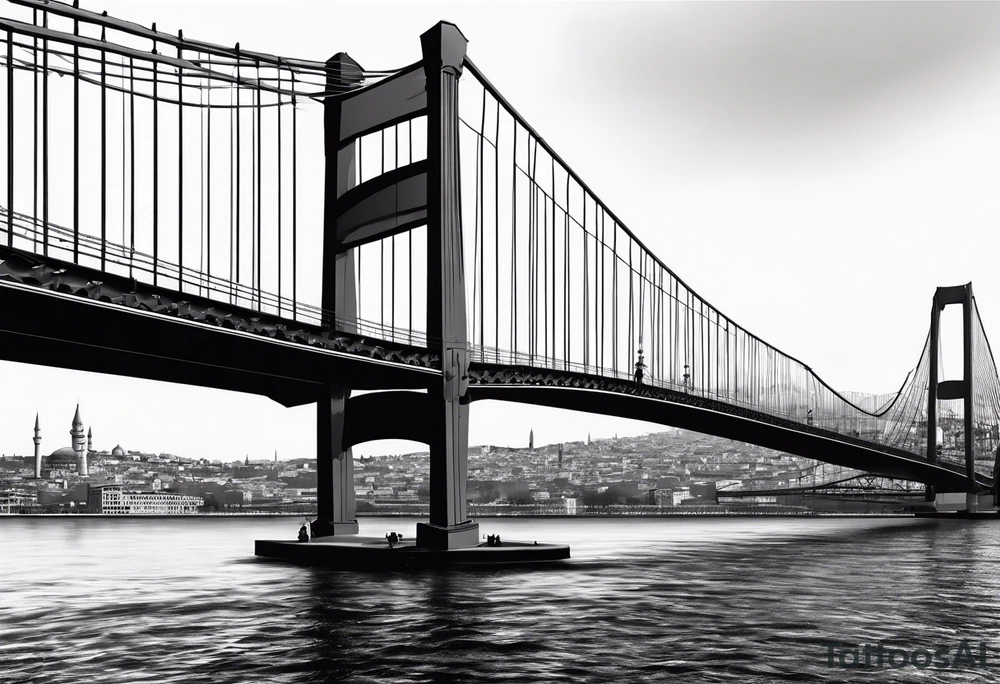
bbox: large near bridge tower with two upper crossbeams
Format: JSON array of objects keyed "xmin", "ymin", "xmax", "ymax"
[{"xmin": 313, "ymin": 22, "xmax": 479, "ymax": 549}]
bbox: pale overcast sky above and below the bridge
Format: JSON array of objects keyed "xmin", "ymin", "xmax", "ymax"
[{"xmin": 0, "ymin": 0, "xmax": 1000, "ymax": 459}]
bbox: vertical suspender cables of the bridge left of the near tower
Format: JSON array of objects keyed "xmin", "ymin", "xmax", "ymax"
[{"xmin": 0, "ymin": 0, "xmax": 402, "ymax": 328}]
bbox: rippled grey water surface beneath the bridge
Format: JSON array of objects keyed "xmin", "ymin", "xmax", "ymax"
[{"xmin": 0, "ymin": 517, "xmax": 1000, "ymax": 684}]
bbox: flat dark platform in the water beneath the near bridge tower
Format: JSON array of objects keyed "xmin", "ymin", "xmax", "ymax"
[{"xmin": 254, "ymin": 537, "xmax": 569, "ymax": 570}]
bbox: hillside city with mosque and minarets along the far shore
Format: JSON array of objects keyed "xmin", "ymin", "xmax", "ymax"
[{"xmin": 0, "ymin": 406, "xmax": 936, "ymax": 516}]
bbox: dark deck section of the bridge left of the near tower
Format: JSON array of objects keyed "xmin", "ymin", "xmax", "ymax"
[{"xmin": 0, "ymin": 248, "xmax": 440, "ymax": 406}]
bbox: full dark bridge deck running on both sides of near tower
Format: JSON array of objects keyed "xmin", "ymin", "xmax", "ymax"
[{"xmin": 0, "ymin": 247, "xmax": 992, "ymax": 490}]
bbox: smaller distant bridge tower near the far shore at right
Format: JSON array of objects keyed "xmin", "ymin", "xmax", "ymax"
[{"xmin": 927, "ymin": 283, "xmax": 980, "ymax": 513}]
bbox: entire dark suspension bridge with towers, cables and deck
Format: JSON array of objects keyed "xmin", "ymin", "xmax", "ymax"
[{"xmin": 0, "ymin": 0, "xmax": 1000, "ymax": 548}]
